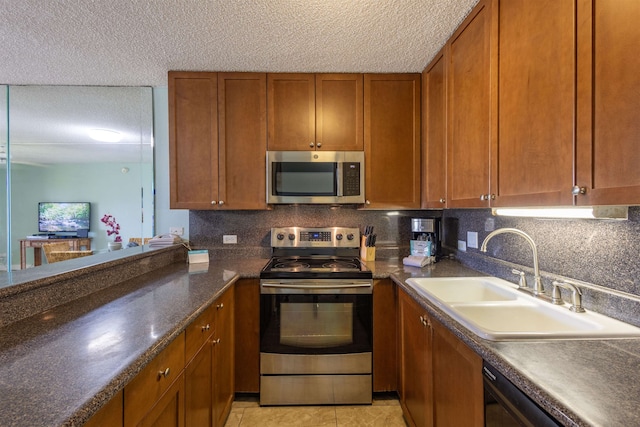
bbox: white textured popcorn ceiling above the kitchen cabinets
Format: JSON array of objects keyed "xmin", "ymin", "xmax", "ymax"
[{"xmin": 0, "ymin": 0, "xmax": 477, "ymax": 86}]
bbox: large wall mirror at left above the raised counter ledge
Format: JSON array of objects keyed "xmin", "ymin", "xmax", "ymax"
[{"xmin": 0, "ymin": 86, "xmax": 154, "ymax": 282}]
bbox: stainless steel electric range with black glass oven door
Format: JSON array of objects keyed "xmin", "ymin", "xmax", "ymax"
[{"xmin": 260, "ymin": 227, "xmax": 373, "ymax": 405}]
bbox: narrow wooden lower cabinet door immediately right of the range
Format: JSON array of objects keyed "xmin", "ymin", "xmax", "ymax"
[{"xmin": 373, "ymin": 279, "xmax": 398, "ymax": 392}]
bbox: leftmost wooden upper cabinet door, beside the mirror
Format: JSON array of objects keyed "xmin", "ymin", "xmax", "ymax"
[{"xmin": 169, "ymin": 72, "xmax": 218, "ymax": 209}]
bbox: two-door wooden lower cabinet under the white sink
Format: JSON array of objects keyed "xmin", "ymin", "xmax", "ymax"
[{"xmin": 398, "ymin": 291, "xmax": 484, "ymax": 427}]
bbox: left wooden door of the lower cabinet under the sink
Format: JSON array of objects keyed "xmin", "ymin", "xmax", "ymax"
[{"xmin": 399, "ymin": 291, "xmax": 432, "ymax": 427}]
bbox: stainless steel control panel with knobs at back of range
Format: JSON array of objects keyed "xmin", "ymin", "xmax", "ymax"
[{"xmin": 271, "ymin": 227, "xmax": 360, "ymax": 248}]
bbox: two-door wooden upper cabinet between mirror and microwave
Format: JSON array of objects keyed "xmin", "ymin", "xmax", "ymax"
[{"xmin": 169, "ymin": 72, "xmax": 267, "ymax": 210}]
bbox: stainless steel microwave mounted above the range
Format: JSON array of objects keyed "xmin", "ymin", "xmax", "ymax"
[{"xmin": 267, "ymin": 151, "xmax": 364, "ymax": 204}]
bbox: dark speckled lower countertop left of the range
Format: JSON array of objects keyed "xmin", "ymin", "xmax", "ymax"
[{"xmin": 0, "ymin": 259, "xmax": 266, "ymax": 427}]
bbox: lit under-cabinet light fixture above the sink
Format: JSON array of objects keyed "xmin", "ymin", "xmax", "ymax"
[{"xmin": 491, "ymin": 206, "xmax": 629, "ymax": 219}]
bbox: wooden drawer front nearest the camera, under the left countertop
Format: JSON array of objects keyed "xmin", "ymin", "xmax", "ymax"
[{"xmin": 124, "ymin": 333, "xmax": 185, "ymax": 426}]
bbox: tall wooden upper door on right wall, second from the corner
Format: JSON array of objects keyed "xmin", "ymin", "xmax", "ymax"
[{"xmin": 446, "ymin": 0, "xmax": 492, "ymax": 208}]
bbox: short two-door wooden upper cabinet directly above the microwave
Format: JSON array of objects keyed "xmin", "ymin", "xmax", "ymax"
[{"xmin": 267, "ymin": 74, "xmax": 363, "ymax": 151}]
